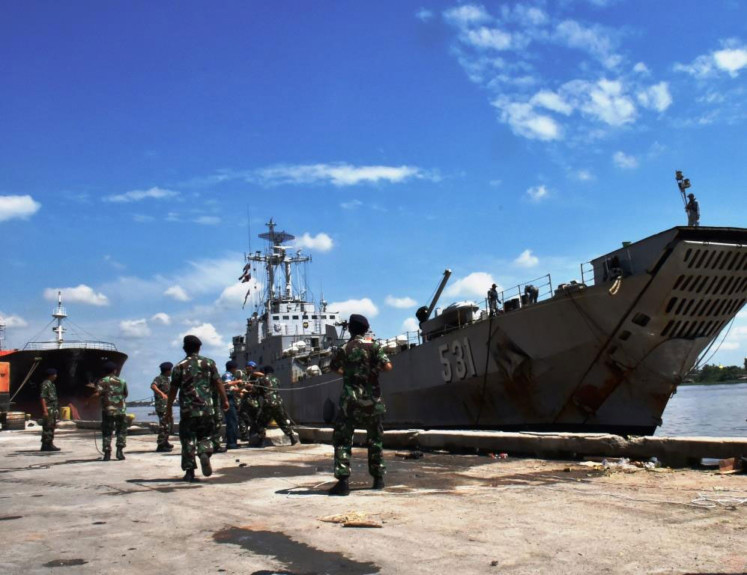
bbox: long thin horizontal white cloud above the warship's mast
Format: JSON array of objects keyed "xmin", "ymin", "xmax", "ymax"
[{"xmin": 256, "ymin": 164, "xmax": 438, "ymax": 187}]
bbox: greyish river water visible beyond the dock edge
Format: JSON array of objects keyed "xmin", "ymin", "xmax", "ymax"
[{"xmin": 127, "ymin": 383, "xmax": 747, "ymax": 437}]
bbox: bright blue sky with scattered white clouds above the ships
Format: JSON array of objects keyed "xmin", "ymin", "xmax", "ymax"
[{"xmin": 0, "ymin": 0, "xmax": 747, "ymax": 396}]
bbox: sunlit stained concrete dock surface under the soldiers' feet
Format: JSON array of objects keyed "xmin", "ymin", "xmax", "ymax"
[{"xmin": 0, "ymin": 427, "xmax": 747, "ymax": 575}]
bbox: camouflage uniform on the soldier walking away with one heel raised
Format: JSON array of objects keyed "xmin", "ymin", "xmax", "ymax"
[{"xmin": 171, "ymin": 353, "xmax": 220, "ymax": 471}]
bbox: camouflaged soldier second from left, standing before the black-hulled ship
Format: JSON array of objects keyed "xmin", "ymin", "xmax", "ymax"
[{"xmin": 96, "ymin": 361, "xmax": 127, "ymax": 461}]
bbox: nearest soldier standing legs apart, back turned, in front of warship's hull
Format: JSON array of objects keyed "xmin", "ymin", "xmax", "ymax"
[{"xmin": 329, "ymin": 314, "xmax": 392, "ymax": 495}]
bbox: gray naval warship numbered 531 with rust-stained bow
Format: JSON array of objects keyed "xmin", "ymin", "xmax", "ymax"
[{"xmin": 231, "ymin": 216, "xmax": 747, "ymax": 435}]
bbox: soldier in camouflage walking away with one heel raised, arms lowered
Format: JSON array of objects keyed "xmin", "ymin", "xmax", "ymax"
[{"xmin": 166, "ymin": 335, "xmax": 228, "ymax": 481}]
